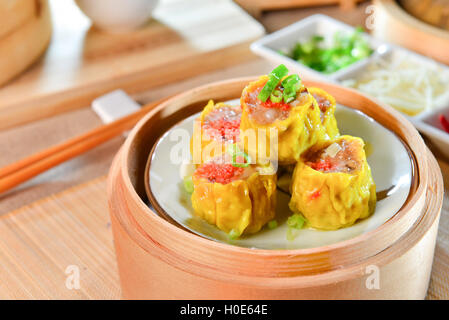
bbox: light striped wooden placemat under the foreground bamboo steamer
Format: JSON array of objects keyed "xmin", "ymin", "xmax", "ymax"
[{"xmin": 0, "ymin": 172, "xmax": 449, "ymax": 299}]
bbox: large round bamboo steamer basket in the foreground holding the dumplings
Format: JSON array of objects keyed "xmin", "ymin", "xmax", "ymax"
[{"xmin": 108, "ymin": 78, "xmax": 443, "ymax": 299}]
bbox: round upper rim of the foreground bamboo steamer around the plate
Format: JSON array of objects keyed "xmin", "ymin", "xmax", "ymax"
[{"xmin": 109, "ymin": 77, "xmax": 429, "ymax": 277}]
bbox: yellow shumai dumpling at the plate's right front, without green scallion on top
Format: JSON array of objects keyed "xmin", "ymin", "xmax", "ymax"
[{"xmin": 289, "ymin": 135, "xmax": 376, "ymax": 230}]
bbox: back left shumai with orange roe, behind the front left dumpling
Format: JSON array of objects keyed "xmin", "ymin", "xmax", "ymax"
[{"xmin": 190, "ymin": 100, "xmax": 242, "ymax": 164}]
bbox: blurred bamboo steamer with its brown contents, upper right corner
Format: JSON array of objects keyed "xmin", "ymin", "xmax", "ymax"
[{"xmin": 373, "ymin": 0, "xmax": 449, "ymax": 64}]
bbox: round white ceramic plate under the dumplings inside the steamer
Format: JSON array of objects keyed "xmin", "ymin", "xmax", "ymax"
[{"xmin": 149, "ymin": 100, "xmax": 412, "ymax": 249}]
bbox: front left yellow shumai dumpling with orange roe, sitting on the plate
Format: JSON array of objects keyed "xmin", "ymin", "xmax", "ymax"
[{"xmin": 191, "ymin": 159, "xmax": 276, "ymax": 236}]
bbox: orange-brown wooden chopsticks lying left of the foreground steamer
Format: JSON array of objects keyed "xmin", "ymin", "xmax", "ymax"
[{"xmin": 0, "ymin": 98, "xmax": 168, "ymax": 194}]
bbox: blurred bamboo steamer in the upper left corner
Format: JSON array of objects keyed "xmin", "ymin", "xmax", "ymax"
[{"xmin": 0, "ymin": 0, "xmax": 51, "ymax": 85}]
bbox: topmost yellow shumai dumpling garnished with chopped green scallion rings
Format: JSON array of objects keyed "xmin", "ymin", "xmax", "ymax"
[{"xmin": 240, "ymin": 65, "xmax": 326, "ymax": 165}]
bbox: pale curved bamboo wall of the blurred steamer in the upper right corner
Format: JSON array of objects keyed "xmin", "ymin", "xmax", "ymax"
[{"xmin": 373, "ymin": 0, "xmax": 449, "ymax": 64}]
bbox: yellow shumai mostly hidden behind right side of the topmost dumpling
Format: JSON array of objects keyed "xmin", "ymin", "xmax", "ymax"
[{"xmin": 308, "ymin": 87, "xmax": 340, "ymax": 140}]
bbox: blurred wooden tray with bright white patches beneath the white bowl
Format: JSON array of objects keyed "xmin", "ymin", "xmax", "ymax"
[{"xmin": 0, "ymin": 0, "xmax": 264, "ymax": 129}]
